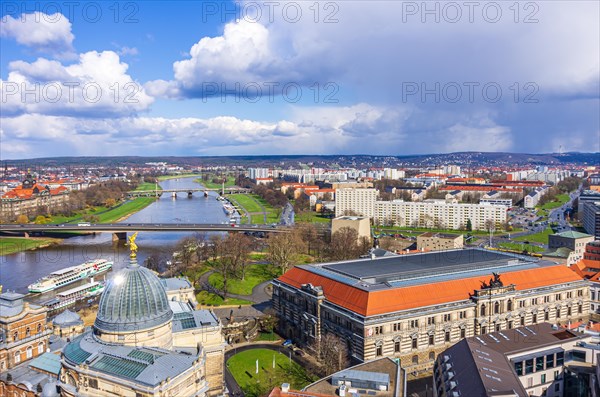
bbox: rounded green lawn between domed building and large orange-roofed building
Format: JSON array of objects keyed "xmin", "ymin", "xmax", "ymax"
[{"xmin": 226, "ymin": 349, "xmax": 316, "ymax": 397}]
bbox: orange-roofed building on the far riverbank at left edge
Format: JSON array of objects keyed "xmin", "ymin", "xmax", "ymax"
[{"xmin": 0, "ymin": 174, "xmax": 69, "ymax": 221}]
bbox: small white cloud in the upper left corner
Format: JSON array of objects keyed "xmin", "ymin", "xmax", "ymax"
[{"xmin": 0, "ymin": 11, "xmax": 75, "ymax": 58}]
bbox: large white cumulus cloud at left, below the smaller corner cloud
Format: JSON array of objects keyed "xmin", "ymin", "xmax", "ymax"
[{"xmin": 0, "ymin": 51, "xmax": 154, "ymax": 118}]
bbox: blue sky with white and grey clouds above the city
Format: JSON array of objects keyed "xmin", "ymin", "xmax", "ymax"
[{"xmin": 0, "ymin": 0, "xmax": 600, "ymax": 160}]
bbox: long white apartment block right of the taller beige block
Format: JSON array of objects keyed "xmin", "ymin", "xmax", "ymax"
[{"xmin": 374, "ymin": 200, "xmax": 507, "ymax": 230}]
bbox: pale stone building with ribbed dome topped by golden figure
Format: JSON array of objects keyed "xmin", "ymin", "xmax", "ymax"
[{"xmin": 59, "ymin": 235, "xmax": 225, "ymax": 397}]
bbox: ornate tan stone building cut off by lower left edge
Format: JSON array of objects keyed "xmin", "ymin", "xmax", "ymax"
[{"xmin": 0, "ymin": 292, "xmax": 52, "ymax": 372}]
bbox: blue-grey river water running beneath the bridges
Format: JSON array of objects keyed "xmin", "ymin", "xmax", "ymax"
[{"xmin": 0, "ymin": 178, "xmax": 229, "ymax": 295}]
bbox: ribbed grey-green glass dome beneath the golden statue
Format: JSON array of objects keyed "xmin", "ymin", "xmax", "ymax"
[{"xmin": 94, "ymin": 259, "xmax": 173, "ymax": 332}]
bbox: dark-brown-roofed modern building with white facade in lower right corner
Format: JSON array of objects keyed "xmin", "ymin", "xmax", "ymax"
[{"xmin": 433, "ymin": 322, "xmax": 598, "ymax": 397}]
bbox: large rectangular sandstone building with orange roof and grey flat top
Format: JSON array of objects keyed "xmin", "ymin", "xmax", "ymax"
[{"xmin": 272, "ymin": 249, "xmax": 590, "ymax": 375}]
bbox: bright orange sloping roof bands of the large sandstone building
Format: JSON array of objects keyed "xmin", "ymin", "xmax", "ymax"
[{"xmin": 279, "ymin": 265, "xmax": 581, "ymax": 316}]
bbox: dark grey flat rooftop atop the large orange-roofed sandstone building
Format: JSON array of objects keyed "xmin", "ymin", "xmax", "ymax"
[{"xmin": 318, "ymin": 248, "xmax": 554, "ymax": 284}]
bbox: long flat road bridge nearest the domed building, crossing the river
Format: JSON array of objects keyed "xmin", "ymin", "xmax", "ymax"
[{"xmin": 0, "ymin": 223, "xmax": 291, "ymax": 240}]
